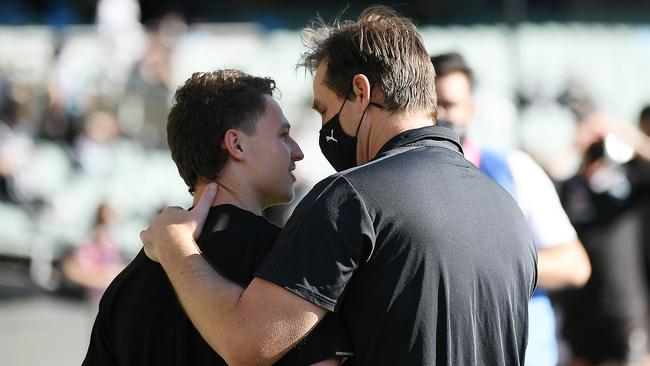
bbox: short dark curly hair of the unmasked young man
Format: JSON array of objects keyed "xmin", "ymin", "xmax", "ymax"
[{"xmin": 167, "ymin": 69, "xmax": 275, "ymax": 193}]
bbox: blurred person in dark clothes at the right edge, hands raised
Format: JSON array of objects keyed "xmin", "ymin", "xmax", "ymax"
[{"xmin": 562, "ymin": 106, "xmax": 650, "ymax": 366}]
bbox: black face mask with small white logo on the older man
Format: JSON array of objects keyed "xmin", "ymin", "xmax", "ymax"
[{"xmin": 318, "ymin": 94, "xmax": 384, "ymax": 172}]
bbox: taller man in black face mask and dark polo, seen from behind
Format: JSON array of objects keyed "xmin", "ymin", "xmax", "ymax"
[{"xmin": 141, "ymin": 7, "xmax": 536, "ymax": 365}]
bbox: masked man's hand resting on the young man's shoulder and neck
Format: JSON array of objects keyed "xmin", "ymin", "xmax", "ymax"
[{"xmin": 140, "ymin": 183, "xmax": 217, "ymax": 263}]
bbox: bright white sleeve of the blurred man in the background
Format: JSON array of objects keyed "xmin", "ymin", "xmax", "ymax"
[{"xmin": 508, "ymin": 151, "xmax": 576, "ymax": 249}]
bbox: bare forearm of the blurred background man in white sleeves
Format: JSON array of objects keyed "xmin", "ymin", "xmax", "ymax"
[{"xmin": 537, "ymin": 239, "xmax": 591, "ymax": 290}]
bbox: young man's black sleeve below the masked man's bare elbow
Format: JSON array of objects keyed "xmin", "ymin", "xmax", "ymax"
[{"xmin": 277, "ymin": 313, "xmax": 353, "ymax": 366}]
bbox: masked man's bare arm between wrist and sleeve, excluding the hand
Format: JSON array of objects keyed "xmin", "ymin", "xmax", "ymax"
[{"xmin": 161, "ymin": 244, "xmax": 318, "ymax": 365}]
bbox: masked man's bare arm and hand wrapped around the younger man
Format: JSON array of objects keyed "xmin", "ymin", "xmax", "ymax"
[{"xmin": 141, "ymin": 187, "xmax": 326, "ymax": 365}]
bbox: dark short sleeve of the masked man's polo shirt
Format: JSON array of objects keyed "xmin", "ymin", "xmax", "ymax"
[{"xmin": 255, "ymin": 174, "xmax": 375, "ymax": 312}]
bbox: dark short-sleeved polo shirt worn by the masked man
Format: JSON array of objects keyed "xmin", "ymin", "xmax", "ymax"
[{"xmin": 255, "ymin": 127, "xmax": 537, "ymax": 365}]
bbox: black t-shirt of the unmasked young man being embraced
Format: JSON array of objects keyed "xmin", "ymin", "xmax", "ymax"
[{"xmin": 83, "ymin": 205, "xmax": 351, "ymax": 366}]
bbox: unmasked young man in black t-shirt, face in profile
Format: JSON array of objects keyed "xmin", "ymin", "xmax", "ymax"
[{"xmin": 83, "ymin": 70, "xmax": 349, "ymax": 366}]
